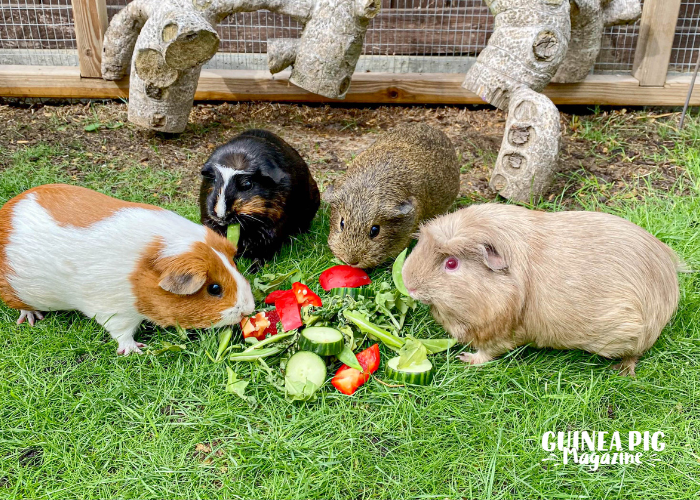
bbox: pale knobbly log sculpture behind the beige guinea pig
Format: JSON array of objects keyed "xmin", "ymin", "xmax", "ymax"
[{"xmin": 462, "ymin": 0, "xmax": 641, "ymax": 202}]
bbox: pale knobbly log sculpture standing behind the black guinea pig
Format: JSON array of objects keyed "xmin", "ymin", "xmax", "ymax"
[{"xmin": 102, "ymin": 0, "xmax": 380, "ymax": 133}]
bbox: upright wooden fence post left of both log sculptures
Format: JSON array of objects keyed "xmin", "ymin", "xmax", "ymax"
[{"xmin": 71, "ymin": 0, "xmax": 107, "ymax": 78}]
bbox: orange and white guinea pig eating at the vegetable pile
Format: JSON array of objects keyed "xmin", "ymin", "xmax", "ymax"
[{"xmin": 0, "ymin": 184, "xmax": 255, "ymax": 355}]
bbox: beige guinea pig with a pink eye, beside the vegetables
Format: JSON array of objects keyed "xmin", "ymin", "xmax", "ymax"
[{"xmin": 402, "ymin": 204, "xmax": 679, "ymax": 375}]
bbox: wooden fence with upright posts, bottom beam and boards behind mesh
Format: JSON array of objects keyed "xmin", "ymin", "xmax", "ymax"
[{"xmin": 0, "ymin": 0, "xmax": 700, "ymax": 106}]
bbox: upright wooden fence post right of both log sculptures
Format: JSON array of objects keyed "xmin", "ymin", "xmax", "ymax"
[{"xmin": 632, "ymin": 0, "xmax": 681, "ymax": 87}]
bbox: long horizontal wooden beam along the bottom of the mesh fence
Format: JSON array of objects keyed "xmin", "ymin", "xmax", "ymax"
[{"xmin": 0, "ymin": 66, "xmax": 700, "ymax": 106}]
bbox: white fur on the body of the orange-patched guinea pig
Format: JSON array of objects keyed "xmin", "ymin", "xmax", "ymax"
[{"xmin": 5, "ymin": 193, "xmax": 206, "ymax": 346}]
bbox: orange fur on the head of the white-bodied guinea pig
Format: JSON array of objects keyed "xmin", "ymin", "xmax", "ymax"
[{"xmin": 129, "ymin": 228, "xmax": 238, "ymax": 328}]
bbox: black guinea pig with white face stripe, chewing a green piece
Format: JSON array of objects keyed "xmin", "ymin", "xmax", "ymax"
[{"xmin": 199, "ymin": 130, "xmax": 320, "ymax": 261}]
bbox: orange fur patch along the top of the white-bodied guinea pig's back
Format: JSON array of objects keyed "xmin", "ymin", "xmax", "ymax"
[{"xmin": 31, "ymin": 184, "xmax": 162, "ymax": 227}]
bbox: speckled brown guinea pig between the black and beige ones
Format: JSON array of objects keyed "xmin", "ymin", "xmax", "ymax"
[{"xmin": 323, "ymin": 124, "xmax": 459, "ymax": 269}]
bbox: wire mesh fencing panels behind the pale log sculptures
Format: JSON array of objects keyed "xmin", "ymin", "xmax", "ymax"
[{"xmin": 0, "ymin": 0, "xmax": 700, "ymax": 73}]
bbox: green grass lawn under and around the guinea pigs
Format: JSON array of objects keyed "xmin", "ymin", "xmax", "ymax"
[{"xmin": 0, "ymin": 102, "xmax": 700, "ymax": 499}]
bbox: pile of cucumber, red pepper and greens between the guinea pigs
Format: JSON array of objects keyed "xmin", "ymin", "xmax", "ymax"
[{"xmin": 207, "ymin": 235, "xmax": 455, "ymax": 401}]
